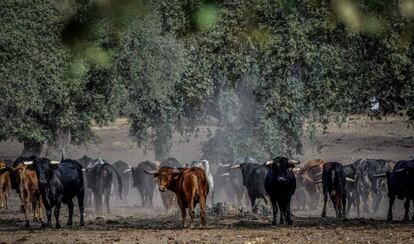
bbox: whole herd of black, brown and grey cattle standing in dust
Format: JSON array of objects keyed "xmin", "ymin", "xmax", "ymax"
[{"xmin": 0, "ymin": 156, "xmax": 414, "ymax": 228}]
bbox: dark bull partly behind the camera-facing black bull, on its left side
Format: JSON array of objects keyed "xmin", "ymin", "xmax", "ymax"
[{"xmin": 231, "ymin": 157, "xmax": 268, "ymax": 213}]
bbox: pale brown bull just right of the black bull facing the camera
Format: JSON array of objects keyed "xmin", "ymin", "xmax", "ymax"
[{"xmin": 295, "ymin": 159, "xmax": 325, "ymax": 209}]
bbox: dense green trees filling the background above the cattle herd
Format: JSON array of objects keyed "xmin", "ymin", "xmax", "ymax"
[{"xmin": 0, "ymin": 0, "xmax": 414, "ymax": 161}]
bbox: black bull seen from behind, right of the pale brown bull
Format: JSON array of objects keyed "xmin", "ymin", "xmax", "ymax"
[{"xmin": 322, "ymin": 162, "xmax": 347, "ymax": 219}]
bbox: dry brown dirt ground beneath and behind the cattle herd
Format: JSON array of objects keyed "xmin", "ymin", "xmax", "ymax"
[{"xmin": 0, "ymin": 117, "xmax": 414, "ymax": 243}]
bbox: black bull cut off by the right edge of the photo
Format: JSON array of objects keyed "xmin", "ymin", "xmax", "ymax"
[{"xmin": 375, "ymin": 160, "xmax": 414, "ymax": 222}]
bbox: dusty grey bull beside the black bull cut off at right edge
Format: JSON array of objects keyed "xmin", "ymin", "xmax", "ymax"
[{"xmin": 353, "ymin": 159, "xmax": 395, "ymax": 213}]
